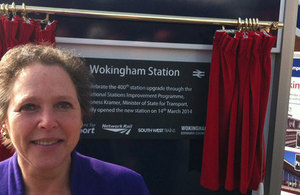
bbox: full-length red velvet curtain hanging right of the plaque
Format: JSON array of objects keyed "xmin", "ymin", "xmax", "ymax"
[{"xmin": 201, "ymin": 31, "xmax": 276, "ymax": 194}]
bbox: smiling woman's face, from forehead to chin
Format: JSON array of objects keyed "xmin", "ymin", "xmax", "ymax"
[{"xmin": 5, "ymin": 63, "xmax": 82, "ymax": 169}]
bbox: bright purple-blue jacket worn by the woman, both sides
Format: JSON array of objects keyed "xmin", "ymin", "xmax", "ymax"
[{"xmin": 0, "ymin": 151, "xmax": 150, "ymax": 195}]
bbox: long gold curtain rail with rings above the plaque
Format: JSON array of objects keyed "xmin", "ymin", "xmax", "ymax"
[{"xmin": 6, "ymin": 3, "xmax": 283, "ymax": 30}]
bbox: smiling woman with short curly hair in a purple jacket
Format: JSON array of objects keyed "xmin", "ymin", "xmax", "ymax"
[{"xmin": 0, "ymin": 45, "xmax": 149, "ymax": 195}]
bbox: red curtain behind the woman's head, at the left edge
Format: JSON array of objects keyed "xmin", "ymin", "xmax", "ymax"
[{"xmin": 0, "ymin": 16, "xmax": 57, "ymax": 161}]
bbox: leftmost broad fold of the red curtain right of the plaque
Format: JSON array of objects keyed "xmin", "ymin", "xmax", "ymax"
[{"xmin": 201, "ymin": 32, "xmax": 226, "ymax": 190}]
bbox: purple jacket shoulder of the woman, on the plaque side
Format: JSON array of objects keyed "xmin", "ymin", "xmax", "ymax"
[{"xmin": 71, "ymin": 152, "xmax": 149, "ymax": 195}]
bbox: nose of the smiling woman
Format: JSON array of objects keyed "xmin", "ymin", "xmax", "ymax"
[{"xmin": 38, "ymin": 108, "xmax": 58, "ymax": 129}]
